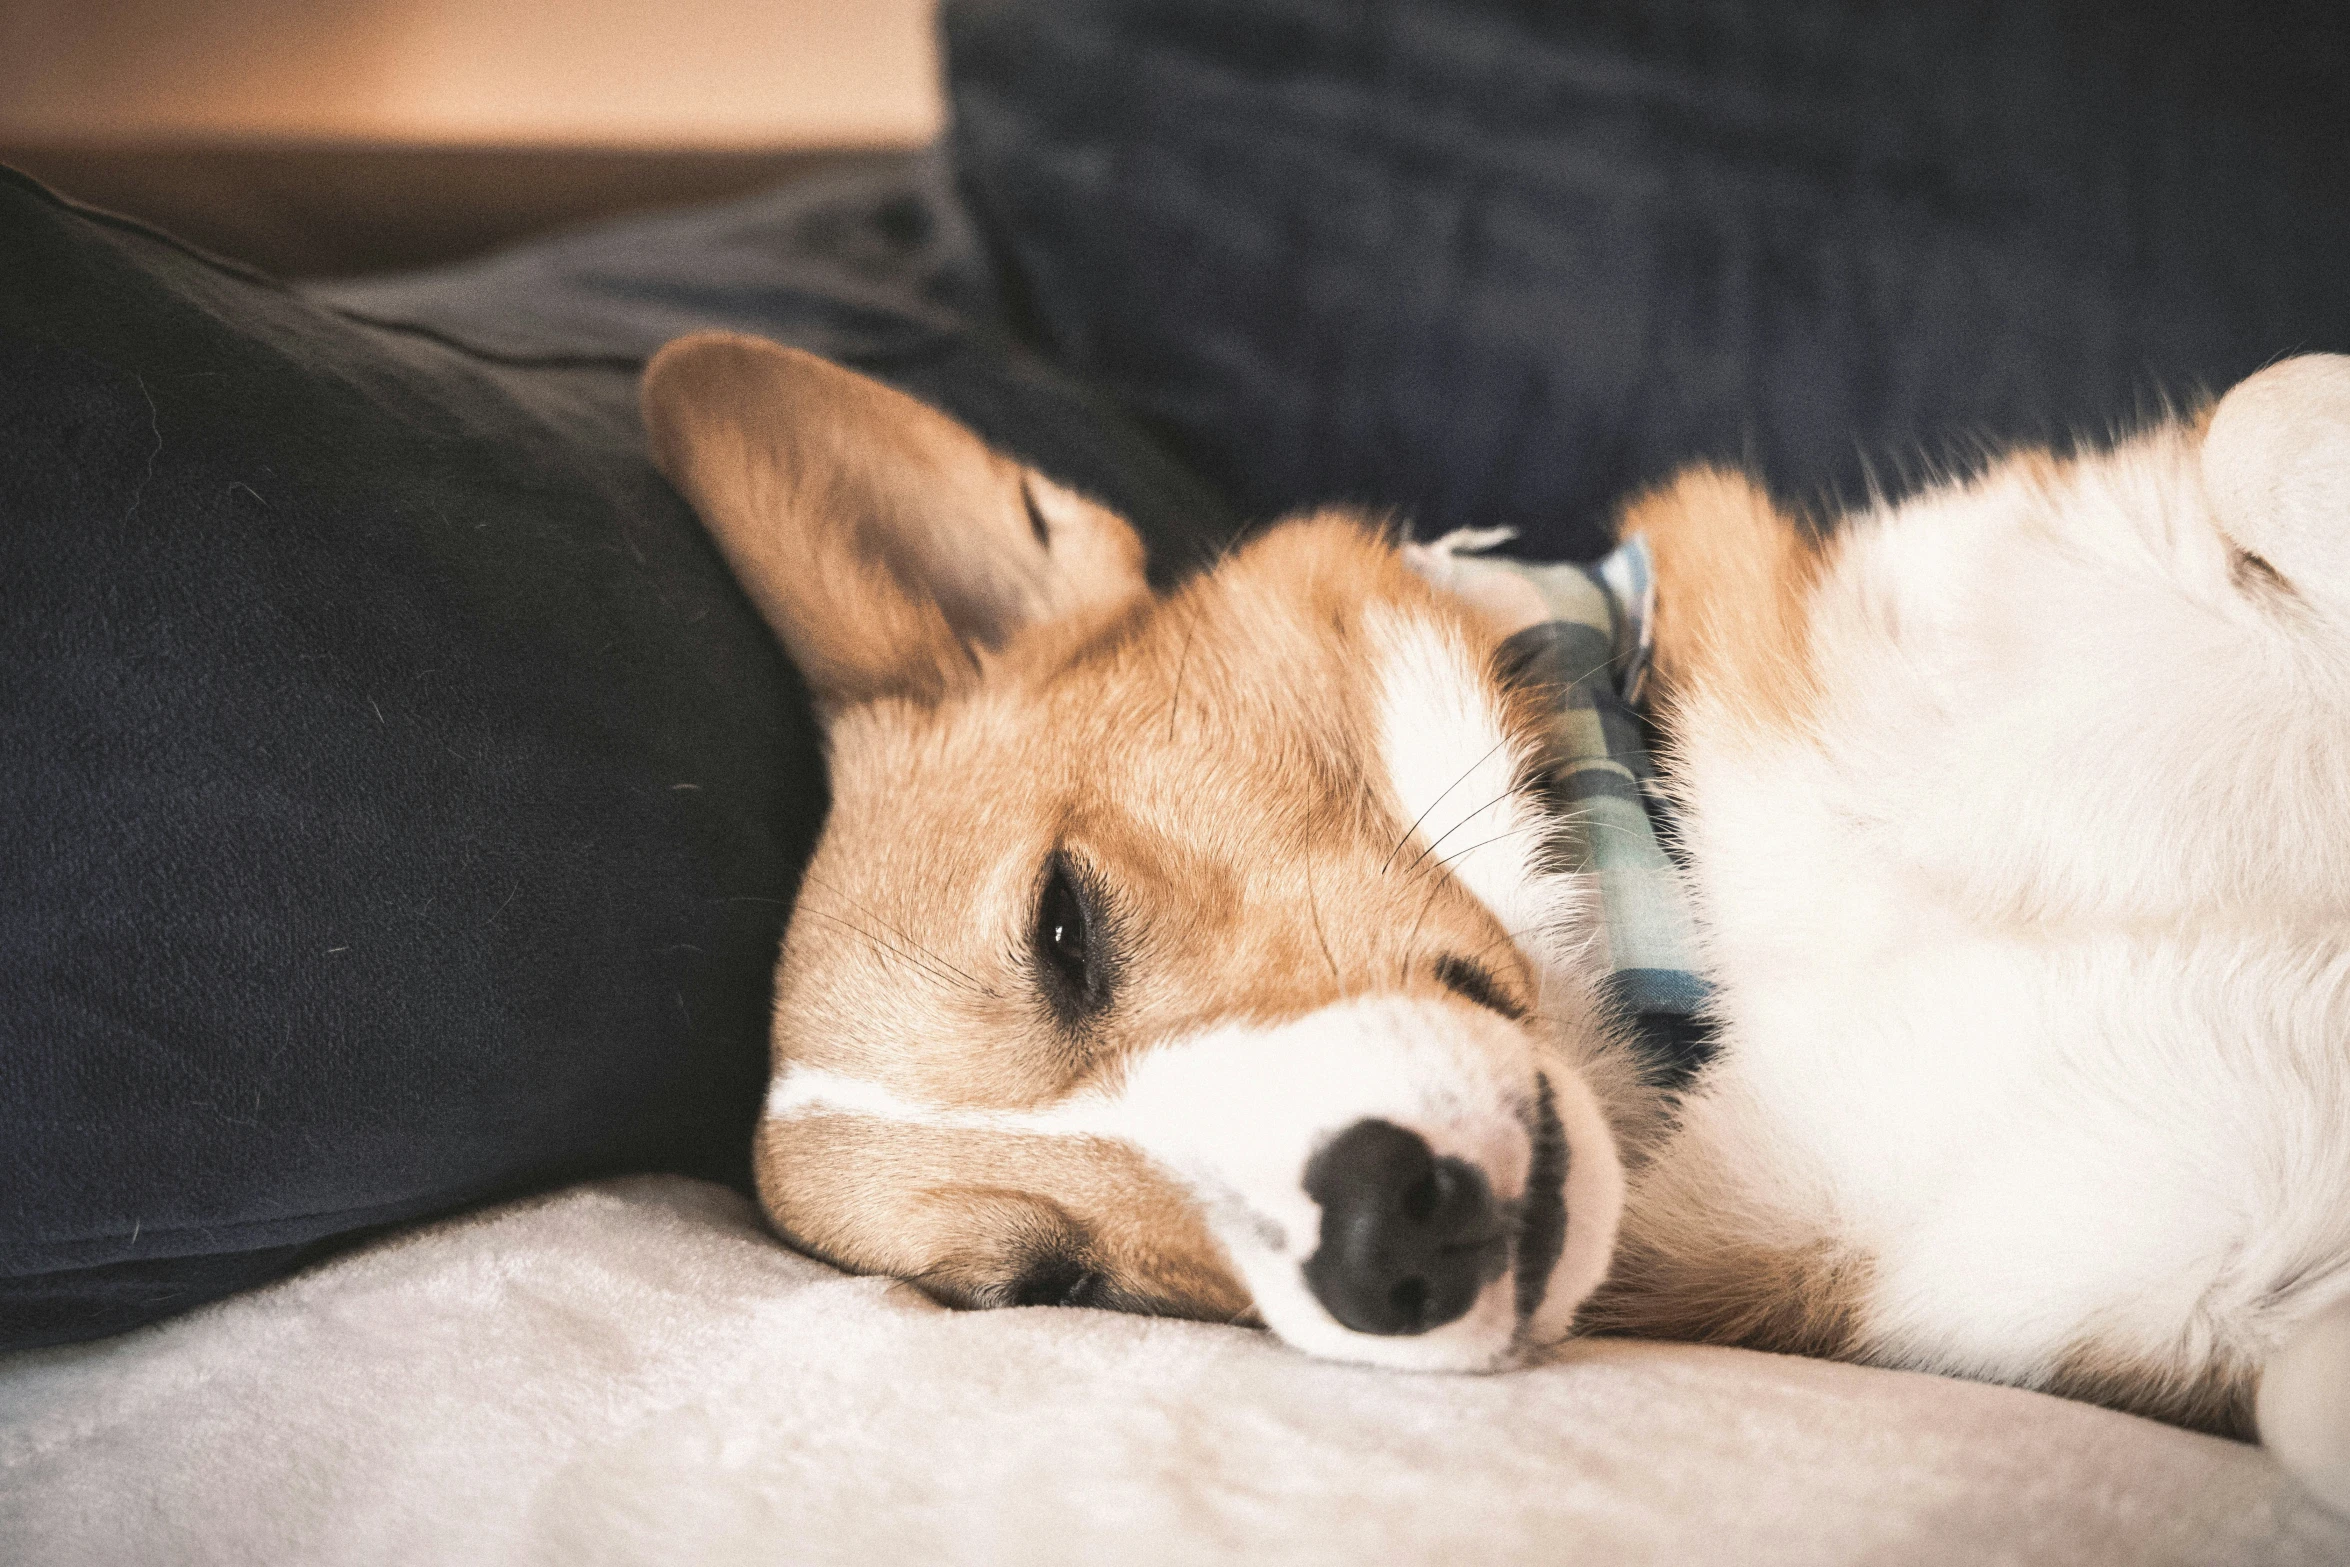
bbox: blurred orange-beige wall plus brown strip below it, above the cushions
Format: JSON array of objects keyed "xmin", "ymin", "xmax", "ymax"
[{"xmin": 0, "ymin": 0, "xmax": 942, "ymax": 275}]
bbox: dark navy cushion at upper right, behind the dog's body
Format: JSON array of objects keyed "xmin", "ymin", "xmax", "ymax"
[{"xmin": 945, "ymin": 0, "xmax": 2350, "ymax": 554}]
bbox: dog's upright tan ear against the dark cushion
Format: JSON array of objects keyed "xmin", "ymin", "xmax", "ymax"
[{"xmin": 642, "ymin": 331, "xmax": 1147, "ymax": 712}]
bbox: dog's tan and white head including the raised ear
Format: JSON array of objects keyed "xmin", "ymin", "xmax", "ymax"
[{"xmin": 644, "ymin": 336, "xmax": 1622, "ymax": 1370}]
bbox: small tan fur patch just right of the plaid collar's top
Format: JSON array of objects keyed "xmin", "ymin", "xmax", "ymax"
[{"xmin": 1619, "ymin": 468, "xmax": 1826, "ymax": 742}]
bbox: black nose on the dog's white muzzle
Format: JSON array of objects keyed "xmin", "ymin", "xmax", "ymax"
[{"xmin": 1307, "ymin": 1121, "xmax": 1509, "ymax": 1334}]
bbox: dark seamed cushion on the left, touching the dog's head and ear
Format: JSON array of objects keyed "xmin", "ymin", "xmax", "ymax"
[{"xmin": 0, "ymin": 160, "xmax": 1220, "ymax": 1349}]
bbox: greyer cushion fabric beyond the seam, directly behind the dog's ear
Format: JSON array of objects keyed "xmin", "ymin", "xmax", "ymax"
[{"xmin": 310, "ymin": 150, "xmax": 1234, "ymax": 583}]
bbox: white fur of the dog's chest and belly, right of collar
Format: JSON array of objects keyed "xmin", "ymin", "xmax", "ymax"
[{"xmin": 1666, "ymin": 362, "xmax": 2350, "ymax": 1494}]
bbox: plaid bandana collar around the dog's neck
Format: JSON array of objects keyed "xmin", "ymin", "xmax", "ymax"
[{"xmin": 1408, "ymin": 529, "xmax": 1711, "ymax": 1083}]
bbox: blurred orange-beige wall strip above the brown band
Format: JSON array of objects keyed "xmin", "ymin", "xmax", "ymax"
[{"xmin": 0, "ymin": 0, "xmax": 942, "ymax": 148}]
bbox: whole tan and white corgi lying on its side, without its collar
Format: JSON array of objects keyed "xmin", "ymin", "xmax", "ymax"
[{"xmin": 644, "ymin": 336, "xmax": 2350, "ymax": 1506}]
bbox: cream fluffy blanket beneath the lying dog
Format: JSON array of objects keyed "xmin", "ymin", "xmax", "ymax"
[{"xmin": 0, "ymin": 1179, "xmax": 2350, "ymax": 1567}]
